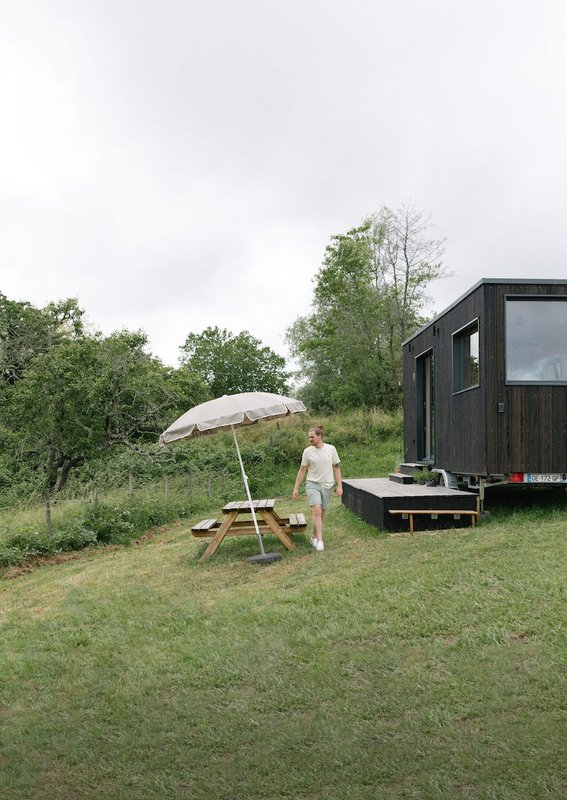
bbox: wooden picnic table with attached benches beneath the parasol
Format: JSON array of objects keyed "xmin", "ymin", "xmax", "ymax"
[{"xmin": 191, "ymin": 498, "xmax": 307, "ymax": 561}]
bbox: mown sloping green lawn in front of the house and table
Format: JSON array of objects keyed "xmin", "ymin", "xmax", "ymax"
[{"xmin": 0, "ymin": 484, "xmax": 567, "ymax": 800}]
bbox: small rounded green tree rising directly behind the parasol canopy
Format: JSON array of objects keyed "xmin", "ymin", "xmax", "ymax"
[{"xmin": 180, "ymin": 327, "xmax": 288, "ymax": 397}]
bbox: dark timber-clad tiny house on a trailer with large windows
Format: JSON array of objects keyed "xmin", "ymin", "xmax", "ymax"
[{"xmin": 403, "ymin": 278, "xmax": 567, "ymax": 494}]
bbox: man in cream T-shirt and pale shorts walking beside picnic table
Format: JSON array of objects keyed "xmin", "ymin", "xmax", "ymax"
[{"xmin": 293, "ymin": 427, "xmax": 343, "ymax": 552}]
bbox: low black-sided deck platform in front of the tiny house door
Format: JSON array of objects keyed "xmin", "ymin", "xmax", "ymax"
[{"xmin": 343, "ymin": 478, "xmax": 479, "ymax": 532}]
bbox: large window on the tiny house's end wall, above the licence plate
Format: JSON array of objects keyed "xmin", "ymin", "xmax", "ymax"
[{"xmin": 506, "ymin": 296, "xmax": 567, "ymax": 383}]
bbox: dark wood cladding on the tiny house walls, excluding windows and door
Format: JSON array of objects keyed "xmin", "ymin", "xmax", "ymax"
[{"xmin": 404, "ymin": 280, "xmax": 567, "ymax": 475}]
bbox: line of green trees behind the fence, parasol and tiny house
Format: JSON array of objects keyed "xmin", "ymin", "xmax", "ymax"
[{"xmin": 0, "ymin": 207, "xmax": 443, "ymax": 504}]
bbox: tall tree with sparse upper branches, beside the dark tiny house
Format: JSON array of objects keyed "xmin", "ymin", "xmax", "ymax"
[{"xmin": 287, "ymin": 207, "xmax": 444, "ymax": 411}]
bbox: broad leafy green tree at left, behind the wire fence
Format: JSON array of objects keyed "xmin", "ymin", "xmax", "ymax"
[{"xmin": 5, "ymin": 331, "xmax": 208, "ymax": 495}]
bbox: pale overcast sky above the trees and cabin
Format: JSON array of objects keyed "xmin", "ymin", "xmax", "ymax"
[{"xmin": 0, "ymin": 0, "xmax": 567, "ymax": 366}]
